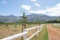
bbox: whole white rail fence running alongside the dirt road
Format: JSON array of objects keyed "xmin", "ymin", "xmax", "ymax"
[{"xmin": 1, "ymin": 24, "xmax": 44, "ymax": 40}]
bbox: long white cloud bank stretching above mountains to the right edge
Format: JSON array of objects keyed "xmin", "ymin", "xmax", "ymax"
[{"xmin": 28, "ymin": 3, "xmax": 60, "ymax": 16}]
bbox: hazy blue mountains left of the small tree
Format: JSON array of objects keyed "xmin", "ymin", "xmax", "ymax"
[{"xmin": 0, "ymin": 15, "xmax": 19, "ymax": 22}]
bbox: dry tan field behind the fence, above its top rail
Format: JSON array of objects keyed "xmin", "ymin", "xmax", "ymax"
[{"xmin": 0, "ymin": 24, "xmax": 37, "ymax": 39}]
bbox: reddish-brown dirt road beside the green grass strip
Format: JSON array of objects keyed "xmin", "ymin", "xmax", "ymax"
[{"xmin": 47, "ymin": 24, "xmax": 60, "ymax": 40}]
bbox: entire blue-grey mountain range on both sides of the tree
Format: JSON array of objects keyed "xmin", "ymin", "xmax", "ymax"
[{"xmin": 0, "ymin": 14, "xmax": 60, "ymax": 22}]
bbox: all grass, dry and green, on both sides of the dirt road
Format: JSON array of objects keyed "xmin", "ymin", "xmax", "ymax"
[{"xmin": 0, "ymin": 23, "xmax": 60, "ymax": 40}]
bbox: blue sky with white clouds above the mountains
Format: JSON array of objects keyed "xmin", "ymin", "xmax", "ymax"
[{"xmin": 0, "ymin": 0, "xmax": 60, "ymax": 16}]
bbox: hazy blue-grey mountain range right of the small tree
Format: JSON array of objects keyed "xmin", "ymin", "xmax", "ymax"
[{"xmin": 27, "ymin": 14, "xmax": 60, "ymax": 21}]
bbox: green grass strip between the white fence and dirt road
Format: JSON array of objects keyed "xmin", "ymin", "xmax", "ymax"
[{"xmin": 32, "ymin": 27, "xmax": 48, "ymax": 40}]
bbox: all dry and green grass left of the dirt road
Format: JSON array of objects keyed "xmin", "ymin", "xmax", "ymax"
[{"xmin": 0, "ymin": 25, "xmax": 48, "ymax": 40}]
